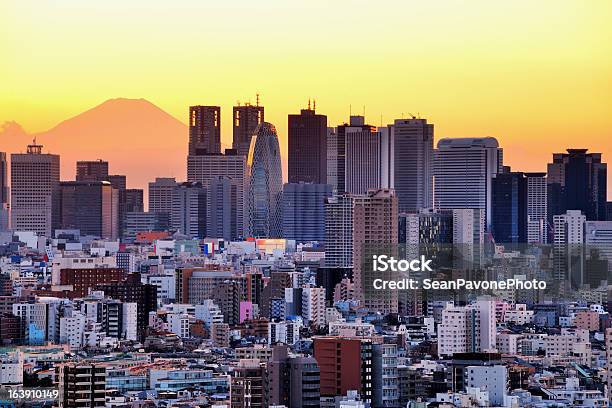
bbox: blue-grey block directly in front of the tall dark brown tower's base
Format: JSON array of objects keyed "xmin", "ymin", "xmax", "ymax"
[{"xmin": 283, "ymin": 183, "xmax": 332, "ymax": 242}]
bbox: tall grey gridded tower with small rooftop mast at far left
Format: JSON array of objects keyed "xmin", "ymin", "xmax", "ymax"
[{"xmin": 11, "ymin": 144, "xmax": 60, "ymax": 237}]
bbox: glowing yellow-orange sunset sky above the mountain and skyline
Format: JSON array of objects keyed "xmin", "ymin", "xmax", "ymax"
[{"xmin": 0, "ymin": 0, "xmax": 612, "ymax": 182}]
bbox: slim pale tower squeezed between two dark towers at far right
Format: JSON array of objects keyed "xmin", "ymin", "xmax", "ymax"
[{"xmin": 525, "ymin": 173, "xmax": 548, "ymax": 244}]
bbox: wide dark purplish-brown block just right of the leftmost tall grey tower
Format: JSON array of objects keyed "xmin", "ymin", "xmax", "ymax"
[{"xmin": 60, "ymin": 181, "xmax": 119, "ymax": 239}]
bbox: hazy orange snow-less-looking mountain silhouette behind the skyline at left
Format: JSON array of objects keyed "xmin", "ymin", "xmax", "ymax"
[{"xmin": 0, "ymin": 98, "xmax": 189, "ymax": 192}]
